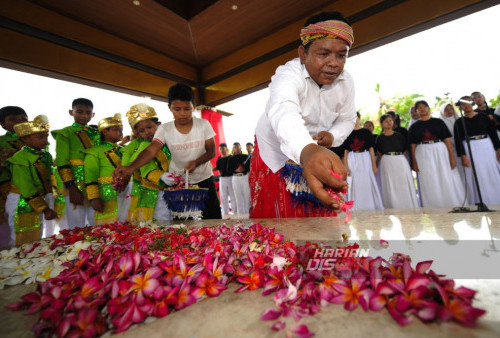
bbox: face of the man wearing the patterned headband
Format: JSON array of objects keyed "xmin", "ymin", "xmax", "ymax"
[{"xmin": 299, "ymin": 39, "xmax": 349, "ymax": 85}]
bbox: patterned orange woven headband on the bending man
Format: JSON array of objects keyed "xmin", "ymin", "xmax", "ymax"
[{"xmin": 300, "ymin": 20, "xmax": 354, "ymax": 48}]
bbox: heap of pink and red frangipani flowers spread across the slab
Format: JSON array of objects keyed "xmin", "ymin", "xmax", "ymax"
[{"xmin": 2, "ymin": 223, "xmax": 485, "ymax": 337}]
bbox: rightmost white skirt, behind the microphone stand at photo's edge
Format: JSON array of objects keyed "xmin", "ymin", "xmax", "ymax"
[{"xmin": 463, "ymin": 138, "xmax": 500, "ymax": 204}]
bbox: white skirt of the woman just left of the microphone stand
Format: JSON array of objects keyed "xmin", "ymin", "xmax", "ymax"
[{"xmin": 415, "ymin": 142, "xmax": 465, "ymax": 208}]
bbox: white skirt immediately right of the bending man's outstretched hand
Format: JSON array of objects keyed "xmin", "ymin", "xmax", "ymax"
[{"xmin": 347, "ymin": 151, "xmax": 384, "ymax": 210}]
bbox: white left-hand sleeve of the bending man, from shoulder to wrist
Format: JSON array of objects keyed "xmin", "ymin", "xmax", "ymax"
[{"xmin": 266, "ymin": 66, "xmax": 315, "ymax": 163}]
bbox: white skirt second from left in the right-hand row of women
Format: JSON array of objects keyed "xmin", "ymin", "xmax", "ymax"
[{"xmin": 379, "ymin": 155, "xmax": 419, "ymax": 209}]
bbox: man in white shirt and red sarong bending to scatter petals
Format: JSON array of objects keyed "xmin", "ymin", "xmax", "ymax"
[{"xmin": 250, "ymin": 12, "xmax": 356, "ymax": 217}]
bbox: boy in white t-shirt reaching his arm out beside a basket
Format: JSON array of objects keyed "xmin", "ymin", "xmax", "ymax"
[{"xmin": 113, "ymin": 83, "xmax": 222, "ymax": 219}]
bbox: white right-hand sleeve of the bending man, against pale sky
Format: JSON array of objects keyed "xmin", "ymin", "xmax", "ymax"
[{"xmin": 329, "ymin": 76, "xmax": 357, "ymax": 147}]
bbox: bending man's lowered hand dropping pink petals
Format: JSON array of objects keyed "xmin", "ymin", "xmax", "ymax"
[{"xmin": 300, "ymin": 143, "xmax": 347, "ymax": 210}]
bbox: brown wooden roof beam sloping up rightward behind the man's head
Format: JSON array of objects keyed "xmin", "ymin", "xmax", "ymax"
[{"xmin": 204, "ymin": 0, "xmax": 492, "ymax": 105}]
